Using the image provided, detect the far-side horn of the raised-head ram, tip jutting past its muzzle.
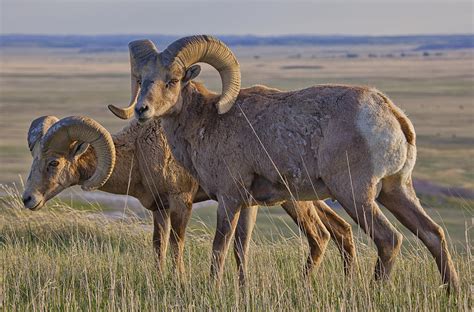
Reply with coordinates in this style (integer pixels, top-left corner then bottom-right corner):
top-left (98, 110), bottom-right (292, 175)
top-left (108, 40), bottom-right (158, 119)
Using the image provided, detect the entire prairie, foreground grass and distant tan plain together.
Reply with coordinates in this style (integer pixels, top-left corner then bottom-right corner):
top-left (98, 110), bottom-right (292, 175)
top-left (0, 47), bottom-right (474, 311)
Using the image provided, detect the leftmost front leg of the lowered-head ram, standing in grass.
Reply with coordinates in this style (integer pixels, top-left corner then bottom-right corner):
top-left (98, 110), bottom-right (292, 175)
top-left (153, 209), bottom-right (170, 271)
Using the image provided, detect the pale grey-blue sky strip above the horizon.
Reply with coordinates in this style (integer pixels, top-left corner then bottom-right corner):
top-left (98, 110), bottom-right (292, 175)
top-left (0, 0), bottom-right (474, 35)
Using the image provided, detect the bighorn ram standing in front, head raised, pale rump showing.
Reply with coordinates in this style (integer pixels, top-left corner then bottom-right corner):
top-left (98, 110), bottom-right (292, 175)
top-left (111, 36), bottom-right (459, 290)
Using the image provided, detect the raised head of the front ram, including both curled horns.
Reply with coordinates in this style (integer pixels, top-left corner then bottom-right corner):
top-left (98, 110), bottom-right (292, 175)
top-left (109, 35), bottom-right (240, 121)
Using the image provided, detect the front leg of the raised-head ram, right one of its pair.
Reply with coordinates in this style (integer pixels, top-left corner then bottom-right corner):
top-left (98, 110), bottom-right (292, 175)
top-left (234, 206), bottom-right (258, 286)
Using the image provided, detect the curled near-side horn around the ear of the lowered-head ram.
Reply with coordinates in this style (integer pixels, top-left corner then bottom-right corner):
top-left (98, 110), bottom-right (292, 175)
top-left (41, 116), bottom-right (115, 190)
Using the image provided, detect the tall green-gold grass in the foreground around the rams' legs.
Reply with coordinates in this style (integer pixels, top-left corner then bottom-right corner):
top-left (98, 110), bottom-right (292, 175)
top-left (0, 189), bottom-right (474, 311)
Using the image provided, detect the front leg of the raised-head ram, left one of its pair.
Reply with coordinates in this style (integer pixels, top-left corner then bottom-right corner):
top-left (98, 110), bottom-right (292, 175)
top-left (211, 196), bottom-right (241, 283)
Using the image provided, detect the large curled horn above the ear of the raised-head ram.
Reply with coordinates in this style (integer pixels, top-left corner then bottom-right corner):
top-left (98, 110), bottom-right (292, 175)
top-left (160, 35), bottom-right (241, 114)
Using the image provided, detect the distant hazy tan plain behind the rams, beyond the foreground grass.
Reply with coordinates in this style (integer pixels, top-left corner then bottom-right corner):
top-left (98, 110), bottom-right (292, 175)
top-left (0, 46), bottom-right (474, 189)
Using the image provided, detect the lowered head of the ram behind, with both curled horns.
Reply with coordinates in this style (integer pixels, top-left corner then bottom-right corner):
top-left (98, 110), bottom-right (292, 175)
top-left (23, 116), bottom-right (115, 210)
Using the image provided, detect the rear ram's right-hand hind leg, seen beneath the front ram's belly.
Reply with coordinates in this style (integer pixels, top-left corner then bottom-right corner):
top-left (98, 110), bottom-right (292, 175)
top-left (313, 200), bottom-right (356, 275)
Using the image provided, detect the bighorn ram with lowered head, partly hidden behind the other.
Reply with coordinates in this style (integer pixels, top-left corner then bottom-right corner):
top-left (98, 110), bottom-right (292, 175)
top-left (23, 116), bottom-right (355, 279)
